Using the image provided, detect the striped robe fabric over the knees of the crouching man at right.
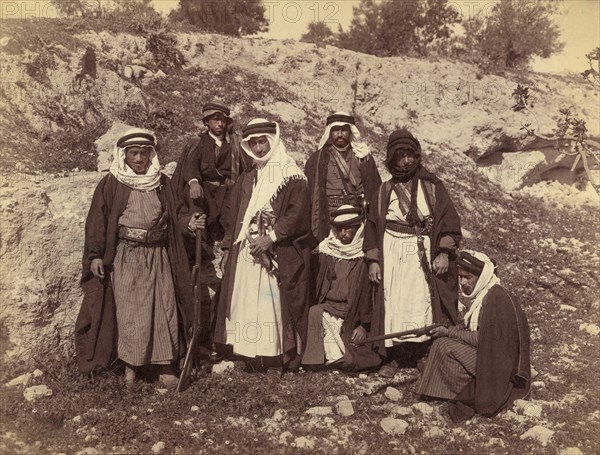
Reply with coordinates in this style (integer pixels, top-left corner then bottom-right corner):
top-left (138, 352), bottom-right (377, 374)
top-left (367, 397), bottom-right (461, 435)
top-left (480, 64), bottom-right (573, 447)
top-left (418, 337), bottom-right (477, 400)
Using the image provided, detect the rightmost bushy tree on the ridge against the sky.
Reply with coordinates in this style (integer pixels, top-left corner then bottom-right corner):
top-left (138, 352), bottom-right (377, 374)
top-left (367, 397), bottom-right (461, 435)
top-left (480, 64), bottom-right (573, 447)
top-left (466, 0), bottom-right (563, 69)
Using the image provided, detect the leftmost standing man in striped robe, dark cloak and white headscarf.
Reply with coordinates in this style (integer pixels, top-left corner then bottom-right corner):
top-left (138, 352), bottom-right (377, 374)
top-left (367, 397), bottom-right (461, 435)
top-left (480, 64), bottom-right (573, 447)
top-left (75, 128), bottom-right (192, 386)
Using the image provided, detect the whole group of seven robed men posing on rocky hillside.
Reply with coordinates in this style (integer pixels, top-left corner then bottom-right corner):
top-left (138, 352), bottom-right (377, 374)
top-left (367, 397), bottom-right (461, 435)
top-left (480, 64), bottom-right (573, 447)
top-left (77, 102), bottom-right (529, 418)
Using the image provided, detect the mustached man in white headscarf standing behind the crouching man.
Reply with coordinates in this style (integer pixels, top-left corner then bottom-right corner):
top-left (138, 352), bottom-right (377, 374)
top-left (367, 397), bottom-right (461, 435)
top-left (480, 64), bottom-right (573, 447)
top-left (305, 112), bottom-right (381, 242)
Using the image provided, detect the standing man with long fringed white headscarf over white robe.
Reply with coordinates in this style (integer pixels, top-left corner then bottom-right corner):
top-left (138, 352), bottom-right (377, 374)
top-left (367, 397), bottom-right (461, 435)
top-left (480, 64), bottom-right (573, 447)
top-left (215, 119), bottom-right (309, 374)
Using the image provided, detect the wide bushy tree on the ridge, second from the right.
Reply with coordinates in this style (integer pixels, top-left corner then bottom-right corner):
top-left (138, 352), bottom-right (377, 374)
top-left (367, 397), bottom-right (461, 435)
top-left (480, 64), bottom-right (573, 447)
top-left (338, 0), bottom-right (460, 56)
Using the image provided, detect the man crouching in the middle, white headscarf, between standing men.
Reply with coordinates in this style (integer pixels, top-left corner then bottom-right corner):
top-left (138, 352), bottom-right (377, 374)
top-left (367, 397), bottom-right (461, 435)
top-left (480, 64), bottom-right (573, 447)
top-left (302, 205), bottom-right (380, 370)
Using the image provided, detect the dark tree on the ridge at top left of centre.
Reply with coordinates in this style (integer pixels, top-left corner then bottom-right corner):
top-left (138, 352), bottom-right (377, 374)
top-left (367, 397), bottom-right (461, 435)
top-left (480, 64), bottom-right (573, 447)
top-left (170, 0), bottom-right (269, 36)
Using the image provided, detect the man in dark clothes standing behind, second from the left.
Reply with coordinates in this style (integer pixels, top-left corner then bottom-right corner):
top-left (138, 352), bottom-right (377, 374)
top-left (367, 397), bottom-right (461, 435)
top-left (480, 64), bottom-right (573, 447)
top-left (172, 101), bottom-right (249, 356)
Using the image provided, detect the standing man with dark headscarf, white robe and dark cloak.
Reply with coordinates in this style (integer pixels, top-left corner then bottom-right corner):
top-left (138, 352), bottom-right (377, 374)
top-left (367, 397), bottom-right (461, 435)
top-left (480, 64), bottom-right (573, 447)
top-left (363, 129), bottom-right (461, 377)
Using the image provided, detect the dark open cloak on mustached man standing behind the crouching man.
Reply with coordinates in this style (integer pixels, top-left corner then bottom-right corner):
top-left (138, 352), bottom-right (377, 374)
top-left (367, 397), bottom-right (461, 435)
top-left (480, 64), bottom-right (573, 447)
top-left (304, 146), bottom-right (381, 246)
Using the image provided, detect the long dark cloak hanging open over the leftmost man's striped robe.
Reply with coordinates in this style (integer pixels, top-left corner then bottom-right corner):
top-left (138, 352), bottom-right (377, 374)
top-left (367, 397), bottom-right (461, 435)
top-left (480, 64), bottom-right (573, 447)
top-left (75, 174), bottom-right (192, 373)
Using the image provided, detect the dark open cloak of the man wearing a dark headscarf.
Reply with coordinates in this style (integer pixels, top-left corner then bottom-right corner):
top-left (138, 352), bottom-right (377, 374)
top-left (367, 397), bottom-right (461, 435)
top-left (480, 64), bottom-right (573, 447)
top-left (363, 169), bottom-right (462, 356)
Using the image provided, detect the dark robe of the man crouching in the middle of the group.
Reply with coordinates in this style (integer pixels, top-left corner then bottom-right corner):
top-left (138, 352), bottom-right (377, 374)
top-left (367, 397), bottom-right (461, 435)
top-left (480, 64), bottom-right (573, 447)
top-left (302, 253), bottom-right (379, 370)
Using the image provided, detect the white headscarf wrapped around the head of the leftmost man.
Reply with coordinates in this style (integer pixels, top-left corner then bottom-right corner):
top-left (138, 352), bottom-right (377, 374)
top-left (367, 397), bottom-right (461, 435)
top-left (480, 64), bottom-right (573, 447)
top-left (109, 128), bottom-right (160, 191)
